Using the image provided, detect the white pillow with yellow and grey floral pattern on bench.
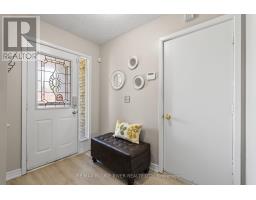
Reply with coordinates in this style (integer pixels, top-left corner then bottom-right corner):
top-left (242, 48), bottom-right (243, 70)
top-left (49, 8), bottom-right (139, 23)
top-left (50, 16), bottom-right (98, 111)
top-left (114, 120), bottom-right (142, 144)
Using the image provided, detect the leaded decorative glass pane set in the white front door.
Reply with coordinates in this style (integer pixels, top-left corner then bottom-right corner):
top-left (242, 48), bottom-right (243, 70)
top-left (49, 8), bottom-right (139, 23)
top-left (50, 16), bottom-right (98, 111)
top-left (37, 54), bottom-right (71, 108)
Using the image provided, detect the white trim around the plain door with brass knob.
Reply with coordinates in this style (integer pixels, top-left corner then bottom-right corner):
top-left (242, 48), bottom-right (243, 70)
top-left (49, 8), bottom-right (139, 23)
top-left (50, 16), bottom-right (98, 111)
top-left (158, 15), bottom-right (242, 184)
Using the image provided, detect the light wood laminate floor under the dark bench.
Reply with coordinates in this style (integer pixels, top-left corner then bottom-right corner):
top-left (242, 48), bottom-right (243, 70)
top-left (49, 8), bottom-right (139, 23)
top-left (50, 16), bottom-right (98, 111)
top-left (7, 153), bottom-right (185, 185)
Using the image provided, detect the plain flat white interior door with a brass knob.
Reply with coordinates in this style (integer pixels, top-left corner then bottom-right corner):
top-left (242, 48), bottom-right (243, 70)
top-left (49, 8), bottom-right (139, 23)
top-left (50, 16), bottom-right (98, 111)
top-left (164, 21), bottom-right (234, 184)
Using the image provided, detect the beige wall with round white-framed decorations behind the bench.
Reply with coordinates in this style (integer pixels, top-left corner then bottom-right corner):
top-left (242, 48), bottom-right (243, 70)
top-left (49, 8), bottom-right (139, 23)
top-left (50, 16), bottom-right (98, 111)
top-left (100, 15), bottom-right (220, 163)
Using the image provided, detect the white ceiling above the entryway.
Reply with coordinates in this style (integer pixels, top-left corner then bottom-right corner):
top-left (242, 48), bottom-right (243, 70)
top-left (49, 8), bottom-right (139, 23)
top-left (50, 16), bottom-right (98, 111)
top-left (40, 14), bottom-right (160, 44)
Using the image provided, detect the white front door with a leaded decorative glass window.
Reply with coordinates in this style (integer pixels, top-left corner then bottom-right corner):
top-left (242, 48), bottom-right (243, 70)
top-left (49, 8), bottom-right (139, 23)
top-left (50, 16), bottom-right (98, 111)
top-left (27, 45), bottom-right (78, 170)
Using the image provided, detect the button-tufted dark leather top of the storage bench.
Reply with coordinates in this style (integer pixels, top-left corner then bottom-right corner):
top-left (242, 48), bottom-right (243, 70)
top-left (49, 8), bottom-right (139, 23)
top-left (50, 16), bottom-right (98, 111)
top-left (92, 132), bottom-right (150, 158)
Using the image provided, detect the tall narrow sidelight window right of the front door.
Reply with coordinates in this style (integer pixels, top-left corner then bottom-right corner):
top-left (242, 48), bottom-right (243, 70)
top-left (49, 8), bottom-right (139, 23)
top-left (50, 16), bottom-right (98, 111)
top-left (79, 58), bottom-right (89, 141)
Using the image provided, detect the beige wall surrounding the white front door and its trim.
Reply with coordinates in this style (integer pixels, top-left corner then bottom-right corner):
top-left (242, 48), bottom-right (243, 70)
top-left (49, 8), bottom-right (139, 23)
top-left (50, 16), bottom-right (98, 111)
top-left (7, 21), bottom-right (99, 171)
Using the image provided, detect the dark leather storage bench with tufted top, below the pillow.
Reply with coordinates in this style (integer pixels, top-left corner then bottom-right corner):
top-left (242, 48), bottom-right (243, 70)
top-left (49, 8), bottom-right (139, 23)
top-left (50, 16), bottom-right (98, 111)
top-left (91, 133), bottom-right (150, 184)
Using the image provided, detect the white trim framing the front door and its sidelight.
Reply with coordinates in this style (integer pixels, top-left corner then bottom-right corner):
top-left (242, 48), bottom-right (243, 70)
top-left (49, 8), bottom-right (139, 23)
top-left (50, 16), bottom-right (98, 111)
top-left (21, 40), bottom-right (92, 175)
